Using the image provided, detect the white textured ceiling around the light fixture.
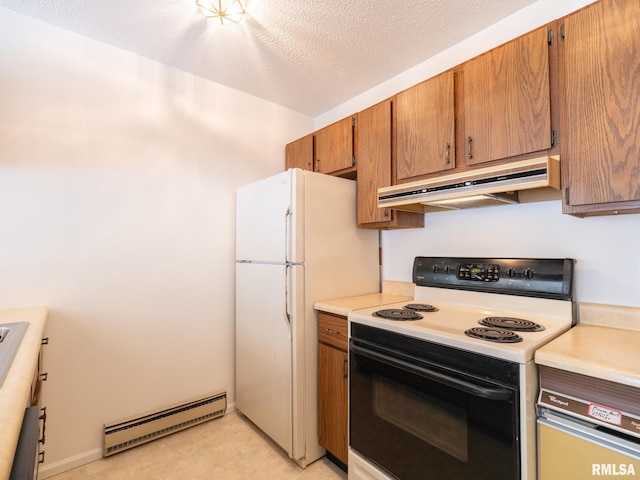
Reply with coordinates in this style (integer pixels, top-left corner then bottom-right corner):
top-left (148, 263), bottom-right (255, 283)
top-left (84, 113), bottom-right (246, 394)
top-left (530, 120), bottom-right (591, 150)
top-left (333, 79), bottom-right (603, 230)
top-left (0, 0), bottom-right (535, 117)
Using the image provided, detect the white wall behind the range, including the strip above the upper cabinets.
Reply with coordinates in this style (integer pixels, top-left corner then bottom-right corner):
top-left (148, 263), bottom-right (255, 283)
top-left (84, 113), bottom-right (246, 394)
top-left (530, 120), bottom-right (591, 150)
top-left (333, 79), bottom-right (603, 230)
top-left (314, 0), bottom-right (640, 306)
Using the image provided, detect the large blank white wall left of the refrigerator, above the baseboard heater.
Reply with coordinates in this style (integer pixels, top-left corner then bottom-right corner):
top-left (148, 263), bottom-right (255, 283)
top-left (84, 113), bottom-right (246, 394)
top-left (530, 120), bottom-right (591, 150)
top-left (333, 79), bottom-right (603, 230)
top-left (0, 9), bottom-right (313, 475)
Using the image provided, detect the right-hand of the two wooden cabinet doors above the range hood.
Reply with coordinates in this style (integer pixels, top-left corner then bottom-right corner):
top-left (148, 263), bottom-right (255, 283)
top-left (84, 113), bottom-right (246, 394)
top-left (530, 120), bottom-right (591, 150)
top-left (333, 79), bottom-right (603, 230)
top-left (461, 27), bottom-right (551, 165)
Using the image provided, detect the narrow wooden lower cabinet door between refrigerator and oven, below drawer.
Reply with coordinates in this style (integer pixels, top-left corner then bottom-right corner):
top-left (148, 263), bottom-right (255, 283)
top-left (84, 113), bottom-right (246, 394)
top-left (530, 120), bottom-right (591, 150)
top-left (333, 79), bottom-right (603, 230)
top-left (318, 343), bottom-right (349, 465)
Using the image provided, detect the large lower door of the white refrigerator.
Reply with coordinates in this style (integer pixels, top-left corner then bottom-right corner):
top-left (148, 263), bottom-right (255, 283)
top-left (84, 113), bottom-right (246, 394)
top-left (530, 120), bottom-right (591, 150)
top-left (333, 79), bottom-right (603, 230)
top-left (236, 263), bottom-right (293, 456)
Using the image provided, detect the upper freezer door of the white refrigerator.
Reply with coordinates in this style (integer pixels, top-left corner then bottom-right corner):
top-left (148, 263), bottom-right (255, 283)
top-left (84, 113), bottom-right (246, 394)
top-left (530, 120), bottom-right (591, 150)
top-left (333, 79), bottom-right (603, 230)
top-left (236, 170), bottom-right (304, 263)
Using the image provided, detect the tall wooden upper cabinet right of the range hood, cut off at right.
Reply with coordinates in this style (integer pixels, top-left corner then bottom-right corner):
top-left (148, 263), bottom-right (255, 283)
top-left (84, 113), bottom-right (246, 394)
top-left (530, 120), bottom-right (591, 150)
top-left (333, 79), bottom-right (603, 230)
top-left (560, 0), bottom-right (640, 213)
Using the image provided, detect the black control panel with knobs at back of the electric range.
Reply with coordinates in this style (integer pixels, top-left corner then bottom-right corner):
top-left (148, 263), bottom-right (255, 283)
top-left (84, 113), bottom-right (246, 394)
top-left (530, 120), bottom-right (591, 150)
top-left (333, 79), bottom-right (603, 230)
top-left (413, 257), bottom-right (575, 300)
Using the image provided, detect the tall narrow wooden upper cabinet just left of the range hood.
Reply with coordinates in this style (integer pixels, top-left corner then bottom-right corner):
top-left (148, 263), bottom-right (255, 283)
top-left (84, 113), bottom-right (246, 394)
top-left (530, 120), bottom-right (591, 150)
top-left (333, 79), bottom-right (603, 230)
top-left (356, 99), bottom-right (424, 229)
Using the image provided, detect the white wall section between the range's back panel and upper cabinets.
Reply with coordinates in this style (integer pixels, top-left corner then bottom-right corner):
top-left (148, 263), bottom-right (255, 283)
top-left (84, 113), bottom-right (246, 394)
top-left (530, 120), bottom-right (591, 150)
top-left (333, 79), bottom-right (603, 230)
top-left (382, 200), bottom-right (640, 307)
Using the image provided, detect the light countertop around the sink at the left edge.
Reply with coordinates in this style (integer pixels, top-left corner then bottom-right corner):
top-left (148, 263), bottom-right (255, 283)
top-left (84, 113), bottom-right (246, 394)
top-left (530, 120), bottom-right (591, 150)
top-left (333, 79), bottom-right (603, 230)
top-left (0, 307), bottom-right (47, 480)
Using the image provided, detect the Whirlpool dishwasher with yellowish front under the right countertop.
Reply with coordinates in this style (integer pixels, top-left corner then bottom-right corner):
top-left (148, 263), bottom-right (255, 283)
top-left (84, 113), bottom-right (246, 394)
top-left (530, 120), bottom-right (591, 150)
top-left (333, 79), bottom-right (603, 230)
top-left (537, 366), bottom-right (640, 480)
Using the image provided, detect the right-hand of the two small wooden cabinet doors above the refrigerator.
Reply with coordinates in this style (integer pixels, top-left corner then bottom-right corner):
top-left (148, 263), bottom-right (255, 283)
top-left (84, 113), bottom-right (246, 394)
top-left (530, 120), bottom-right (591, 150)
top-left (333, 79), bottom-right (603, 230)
top-left (315, 117), bottom-right (355, 173)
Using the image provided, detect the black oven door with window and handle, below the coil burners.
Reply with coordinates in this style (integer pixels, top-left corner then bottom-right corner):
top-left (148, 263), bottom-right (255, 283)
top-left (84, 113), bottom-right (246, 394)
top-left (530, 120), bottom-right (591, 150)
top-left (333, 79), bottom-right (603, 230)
top-left (349, 325), bottom-right (520, 480)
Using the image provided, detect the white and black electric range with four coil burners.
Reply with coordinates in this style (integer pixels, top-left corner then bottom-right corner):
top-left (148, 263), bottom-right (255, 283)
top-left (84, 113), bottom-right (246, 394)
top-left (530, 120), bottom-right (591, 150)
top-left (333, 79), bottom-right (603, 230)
top-left (349, 257), bottom-right (575, 480)
